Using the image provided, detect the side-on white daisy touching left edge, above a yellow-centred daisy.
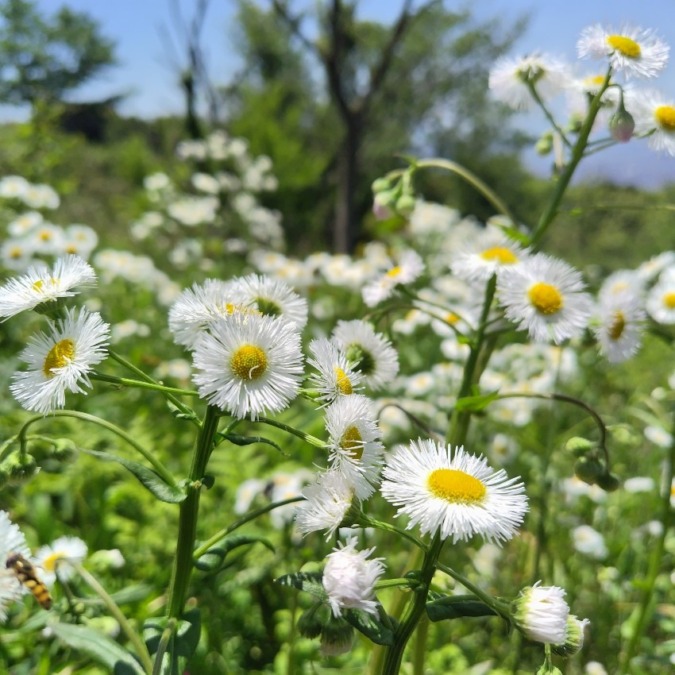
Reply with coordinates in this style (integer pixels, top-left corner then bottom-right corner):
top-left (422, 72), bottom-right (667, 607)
top-left (0, 255), bottom-right (96, 319)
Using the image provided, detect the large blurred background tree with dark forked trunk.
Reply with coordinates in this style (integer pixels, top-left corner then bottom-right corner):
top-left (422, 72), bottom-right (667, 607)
top-left (230, 0), bottom-right (522, 251)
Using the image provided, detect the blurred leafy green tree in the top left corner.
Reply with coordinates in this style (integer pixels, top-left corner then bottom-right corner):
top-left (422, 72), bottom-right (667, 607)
top-left (0, 0), bottom-right (115, 106)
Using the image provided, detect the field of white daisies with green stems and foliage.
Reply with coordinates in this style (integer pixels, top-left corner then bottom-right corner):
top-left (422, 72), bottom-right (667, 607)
top-left (0, 7), bottom-right (675, 675)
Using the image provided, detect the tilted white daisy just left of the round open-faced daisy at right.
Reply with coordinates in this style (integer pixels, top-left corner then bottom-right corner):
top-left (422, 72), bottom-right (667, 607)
top-left (450, 227), bottom-right (527, 281)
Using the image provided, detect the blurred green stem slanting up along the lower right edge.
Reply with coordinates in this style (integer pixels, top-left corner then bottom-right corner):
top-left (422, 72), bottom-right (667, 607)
top-left (618, 415), bottom-right (675, 675)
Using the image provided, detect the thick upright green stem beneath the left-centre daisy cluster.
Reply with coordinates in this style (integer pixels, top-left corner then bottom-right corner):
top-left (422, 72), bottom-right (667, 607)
top-left (168, 406), bottom-right (220, 619)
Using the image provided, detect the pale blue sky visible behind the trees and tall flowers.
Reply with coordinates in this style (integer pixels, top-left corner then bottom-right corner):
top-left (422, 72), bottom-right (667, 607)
top-left (0, 0), bottom-right (675, 182)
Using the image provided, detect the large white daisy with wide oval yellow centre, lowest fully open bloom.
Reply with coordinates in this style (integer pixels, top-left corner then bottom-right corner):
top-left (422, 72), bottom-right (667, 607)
top-left (381, 439), bottom-right (527, 543)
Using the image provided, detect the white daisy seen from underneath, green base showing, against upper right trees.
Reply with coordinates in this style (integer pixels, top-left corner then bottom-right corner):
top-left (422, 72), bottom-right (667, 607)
top-left (489, 54), bottom-right (572, 110)
